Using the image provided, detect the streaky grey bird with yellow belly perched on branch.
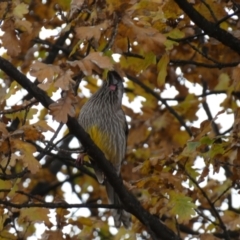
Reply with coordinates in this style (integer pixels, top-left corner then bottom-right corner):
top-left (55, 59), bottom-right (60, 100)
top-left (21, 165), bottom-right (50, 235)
top-left (78, 70), bottom-right (131, 229)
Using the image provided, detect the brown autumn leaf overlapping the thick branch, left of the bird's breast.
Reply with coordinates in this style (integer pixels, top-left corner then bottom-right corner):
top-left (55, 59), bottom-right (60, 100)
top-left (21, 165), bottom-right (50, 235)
top-left (49, 91), bottom-right (77, 123)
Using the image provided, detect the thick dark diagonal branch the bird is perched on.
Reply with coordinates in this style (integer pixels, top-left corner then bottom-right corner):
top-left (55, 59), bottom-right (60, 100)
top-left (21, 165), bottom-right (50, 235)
top-left (0, 57), bottom-right (179, 240)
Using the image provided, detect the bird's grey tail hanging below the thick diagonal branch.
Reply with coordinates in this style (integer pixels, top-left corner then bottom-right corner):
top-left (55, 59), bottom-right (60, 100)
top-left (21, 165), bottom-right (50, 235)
top-left (106, 181), bottom-right (131, 228)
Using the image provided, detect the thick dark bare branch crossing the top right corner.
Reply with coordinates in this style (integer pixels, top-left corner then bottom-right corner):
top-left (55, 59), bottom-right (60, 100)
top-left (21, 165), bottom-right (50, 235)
top-left (175, 0), bottom-right (240, 54)
